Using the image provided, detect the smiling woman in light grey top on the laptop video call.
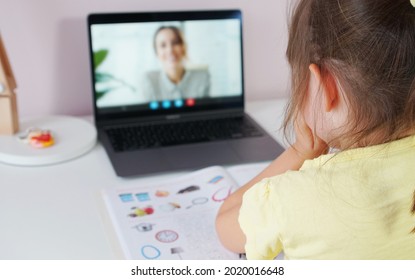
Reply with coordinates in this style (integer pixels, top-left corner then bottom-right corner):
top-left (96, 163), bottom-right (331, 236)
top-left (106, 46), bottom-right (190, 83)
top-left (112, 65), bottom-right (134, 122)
top-left (143, 26), bottom-right (210, 101)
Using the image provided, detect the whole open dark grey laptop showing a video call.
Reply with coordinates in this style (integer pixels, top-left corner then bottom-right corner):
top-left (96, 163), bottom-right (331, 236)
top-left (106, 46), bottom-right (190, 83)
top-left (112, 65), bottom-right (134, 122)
top-left (88, 10), bottom-right (283, 177)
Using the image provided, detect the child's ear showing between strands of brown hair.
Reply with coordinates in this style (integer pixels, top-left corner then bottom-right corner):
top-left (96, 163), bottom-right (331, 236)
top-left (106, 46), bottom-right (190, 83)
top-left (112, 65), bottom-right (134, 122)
top-left (309, 64), bottom-right (339, 112)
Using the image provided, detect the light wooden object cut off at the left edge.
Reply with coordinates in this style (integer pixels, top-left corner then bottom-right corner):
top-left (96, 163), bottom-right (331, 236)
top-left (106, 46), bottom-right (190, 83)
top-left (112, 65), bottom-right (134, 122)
top-left (0, 34), bottom-right (19, 135)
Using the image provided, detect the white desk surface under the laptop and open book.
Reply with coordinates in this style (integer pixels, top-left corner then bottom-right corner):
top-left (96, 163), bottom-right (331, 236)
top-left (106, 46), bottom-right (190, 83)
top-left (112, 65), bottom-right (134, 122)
top-left (0, 99), bottom-right (286, 259)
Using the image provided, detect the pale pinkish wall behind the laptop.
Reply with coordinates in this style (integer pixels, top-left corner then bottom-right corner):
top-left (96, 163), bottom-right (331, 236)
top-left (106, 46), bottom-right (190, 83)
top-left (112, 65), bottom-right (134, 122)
top-left (0, 0), bottom-right (289, 117)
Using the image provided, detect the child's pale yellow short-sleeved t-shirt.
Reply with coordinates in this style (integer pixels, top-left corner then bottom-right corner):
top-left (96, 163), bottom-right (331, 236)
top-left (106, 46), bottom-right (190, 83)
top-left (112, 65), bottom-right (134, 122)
top-left (239, 136), bottom-right (415, 259)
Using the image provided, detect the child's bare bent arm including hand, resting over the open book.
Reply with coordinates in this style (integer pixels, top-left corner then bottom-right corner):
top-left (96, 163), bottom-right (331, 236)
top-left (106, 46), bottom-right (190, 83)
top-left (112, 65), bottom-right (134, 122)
top-left (216, 115), bottom-right (327, 253)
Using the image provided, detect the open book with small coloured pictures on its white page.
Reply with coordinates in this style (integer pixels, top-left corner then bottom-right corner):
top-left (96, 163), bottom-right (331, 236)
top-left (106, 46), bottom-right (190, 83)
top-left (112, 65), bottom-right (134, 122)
top-left (103, 163), bottom-right (268, 260)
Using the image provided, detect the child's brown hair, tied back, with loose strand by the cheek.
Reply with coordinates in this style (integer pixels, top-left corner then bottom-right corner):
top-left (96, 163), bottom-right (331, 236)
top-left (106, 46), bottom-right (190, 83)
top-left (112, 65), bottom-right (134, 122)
top-left (284, 0), bottom-right (415, 149)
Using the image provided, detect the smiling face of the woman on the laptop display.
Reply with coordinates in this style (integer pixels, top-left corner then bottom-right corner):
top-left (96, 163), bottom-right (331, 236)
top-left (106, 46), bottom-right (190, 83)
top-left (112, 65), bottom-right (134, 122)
top-left (155, 28), bottom-right (185, 68)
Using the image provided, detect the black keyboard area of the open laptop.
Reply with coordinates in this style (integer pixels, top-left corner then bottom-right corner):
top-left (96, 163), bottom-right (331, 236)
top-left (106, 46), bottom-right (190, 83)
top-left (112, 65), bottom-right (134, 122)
top-left (106, 117), bottom-right (263, 152)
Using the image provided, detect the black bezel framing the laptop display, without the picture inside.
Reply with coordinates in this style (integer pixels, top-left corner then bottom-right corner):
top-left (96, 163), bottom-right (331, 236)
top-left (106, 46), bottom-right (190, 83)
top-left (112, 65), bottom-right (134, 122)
top-left (88, 10), bottom-right (245, 121)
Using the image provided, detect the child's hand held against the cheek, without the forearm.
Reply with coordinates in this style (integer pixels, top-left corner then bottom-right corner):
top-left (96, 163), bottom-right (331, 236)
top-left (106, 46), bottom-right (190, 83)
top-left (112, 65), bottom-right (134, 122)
top-left (293, 116), bottom-right (328, 160)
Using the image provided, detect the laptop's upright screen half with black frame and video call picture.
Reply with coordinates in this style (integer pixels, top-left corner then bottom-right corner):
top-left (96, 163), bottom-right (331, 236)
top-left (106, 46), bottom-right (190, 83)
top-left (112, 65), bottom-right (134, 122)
top-left (88, 10), bottom-right (244, 121)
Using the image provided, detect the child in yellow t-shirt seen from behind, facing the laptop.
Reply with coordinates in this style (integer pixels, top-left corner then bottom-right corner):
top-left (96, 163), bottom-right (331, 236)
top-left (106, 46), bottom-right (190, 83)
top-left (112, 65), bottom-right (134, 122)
top-left (216, 0), bottom-right (415, 259)
